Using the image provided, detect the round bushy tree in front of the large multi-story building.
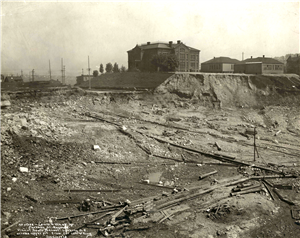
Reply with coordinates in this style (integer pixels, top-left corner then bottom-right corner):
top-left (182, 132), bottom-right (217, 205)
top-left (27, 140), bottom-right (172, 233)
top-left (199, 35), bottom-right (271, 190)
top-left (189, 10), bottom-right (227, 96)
top-left (151, 54), bottom-right (179, 72)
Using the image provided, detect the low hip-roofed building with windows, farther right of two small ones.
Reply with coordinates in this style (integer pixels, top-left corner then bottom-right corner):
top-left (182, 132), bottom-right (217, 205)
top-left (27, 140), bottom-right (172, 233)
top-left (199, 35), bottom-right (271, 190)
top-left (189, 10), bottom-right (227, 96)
top-left (234, 55), bottom-right (284, 74)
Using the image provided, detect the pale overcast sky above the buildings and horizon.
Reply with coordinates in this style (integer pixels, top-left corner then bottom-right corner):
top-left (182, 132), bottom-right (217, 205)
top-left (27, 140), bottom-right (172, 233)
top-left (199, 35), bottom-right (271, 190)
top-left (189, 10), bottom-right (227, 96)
top-left (0, 0), bottom-right (299, 75)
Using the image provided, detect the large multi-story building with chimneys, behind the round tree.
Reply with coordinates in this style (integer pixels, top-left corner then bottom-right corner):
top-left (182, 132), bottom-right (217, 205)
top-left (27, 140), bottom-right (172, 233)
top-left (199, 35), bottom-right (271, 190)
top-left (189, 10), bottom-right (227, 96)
top-left (127, 40), bottom-right (200, 72)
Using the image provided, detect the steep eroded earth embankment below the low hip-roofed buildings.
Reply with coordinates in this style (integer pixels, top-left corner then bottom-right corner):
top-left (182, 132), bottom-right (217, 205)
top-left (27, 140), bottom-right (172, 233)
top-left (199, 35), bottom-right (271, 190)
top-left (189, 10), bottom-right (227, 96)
top-left (155, 73), bottom-right (300, 107)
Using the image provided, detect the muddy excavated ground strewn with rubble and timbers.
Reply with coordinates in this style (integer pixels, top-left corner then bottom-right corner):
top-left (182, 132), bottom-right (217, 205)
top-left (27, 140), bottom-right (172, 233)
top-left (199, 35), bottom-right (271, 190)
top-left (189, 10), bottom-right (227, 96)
top-left (0, 90), bottom-right (300, 238)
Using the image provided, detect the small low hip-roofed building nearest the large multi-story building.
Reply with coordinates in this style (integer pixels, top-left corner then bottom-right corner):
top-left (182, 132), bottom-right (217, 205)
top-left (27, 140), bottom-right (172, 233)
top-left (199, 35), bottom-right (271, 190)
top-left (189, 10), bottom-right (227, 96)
top-left (201, 57), bottom-right (240, 73)
